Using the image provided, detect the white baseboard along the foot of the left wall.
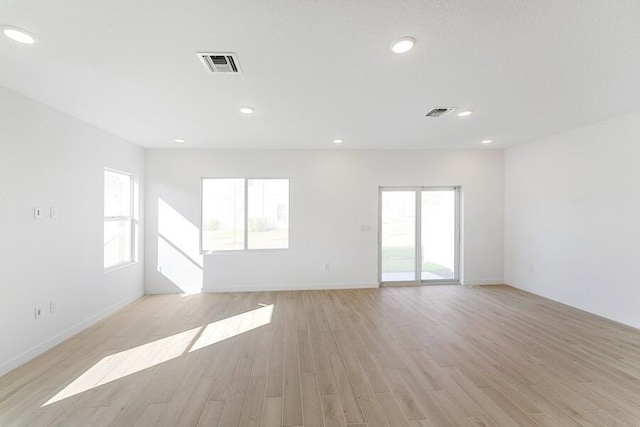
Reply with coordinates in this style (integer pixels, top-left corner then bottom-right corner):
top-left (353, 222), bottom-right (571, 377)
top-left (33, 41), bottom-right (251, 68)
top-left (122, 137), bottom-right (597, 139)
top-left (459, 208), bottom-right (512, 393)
top-left (0, 293), bottom-right (144, 376)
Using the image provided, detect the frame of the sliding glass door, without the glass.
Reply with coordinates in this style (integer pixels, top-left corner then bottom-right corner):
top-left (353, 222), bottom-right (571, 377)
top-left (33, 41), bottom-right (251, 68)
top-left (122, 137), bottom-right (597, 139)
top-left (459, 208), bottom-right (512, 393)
top-left (378, 186), bottom-right (461, 286)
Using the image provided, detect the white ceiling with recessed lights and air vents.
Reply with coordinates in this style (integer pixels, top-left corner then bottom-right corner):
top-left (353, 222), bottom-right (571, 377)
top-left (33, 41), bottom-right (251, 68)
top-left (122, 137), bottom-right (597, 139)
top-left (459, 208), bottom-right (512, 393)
top-left (0, 0), bottom-right (640, 149)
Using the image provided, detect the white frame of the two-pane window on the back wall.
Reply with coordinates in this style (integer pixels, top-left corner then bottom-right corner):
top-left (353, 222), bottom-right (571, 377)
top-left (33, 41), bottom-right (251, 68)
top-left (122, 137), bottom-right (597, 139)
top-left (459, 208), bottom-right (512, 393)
top-left (199, 176), bottom-right (291, 255)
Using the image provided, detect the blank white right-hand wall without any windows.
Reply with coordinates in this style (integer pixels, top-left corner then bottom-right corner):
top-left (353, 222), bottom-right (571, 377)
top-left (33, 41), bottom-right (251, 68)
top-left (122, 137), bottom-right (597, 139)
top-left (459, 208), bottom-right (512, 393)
top-left (505, 112), bottom-right (640, 328)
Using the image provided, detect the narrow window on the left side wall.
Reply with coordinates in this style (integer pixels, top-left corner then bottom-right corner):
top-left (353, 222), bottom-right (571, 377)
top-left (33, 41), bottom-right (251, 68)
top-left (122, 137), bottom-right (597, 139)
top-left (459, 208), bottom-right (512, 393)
top-left (104, 170), bottom-right (135, 270)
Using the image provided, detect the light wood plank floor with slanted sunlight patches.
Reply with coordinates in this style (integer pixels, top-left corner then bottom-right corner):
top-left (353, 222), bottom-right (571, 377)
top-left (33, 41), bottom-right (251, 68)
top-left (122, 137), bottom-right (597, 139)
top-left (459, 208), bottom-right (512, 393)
top-left (0, 286), bottom-right (640, 427)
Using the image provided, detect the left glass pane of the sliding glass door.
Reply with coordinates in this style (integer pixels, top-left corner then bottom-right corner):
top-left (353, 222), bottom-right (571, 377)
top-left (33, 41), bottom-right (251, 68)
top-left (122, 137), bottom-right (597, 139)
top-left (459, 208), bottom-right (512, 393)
top-left (381, 191), bottom-right (416, 282)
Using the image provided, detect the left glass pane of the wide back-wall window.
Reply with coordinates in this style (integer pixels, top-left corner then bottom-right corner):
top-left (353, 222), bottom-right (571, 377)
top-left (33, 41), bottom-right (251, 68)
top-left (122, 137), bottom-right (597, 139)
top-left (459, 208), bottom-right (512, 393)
top-left (202, 179), bottom-right (244, 251)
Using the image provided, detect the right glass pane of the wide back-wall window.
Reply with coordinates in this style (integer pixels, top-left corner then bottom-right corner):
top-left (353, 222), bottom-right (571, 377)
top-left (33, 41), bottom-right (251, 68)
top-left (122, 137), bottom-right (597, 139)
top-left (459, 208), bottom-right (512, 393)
top-left (247, 179), bottom-right (289, 249)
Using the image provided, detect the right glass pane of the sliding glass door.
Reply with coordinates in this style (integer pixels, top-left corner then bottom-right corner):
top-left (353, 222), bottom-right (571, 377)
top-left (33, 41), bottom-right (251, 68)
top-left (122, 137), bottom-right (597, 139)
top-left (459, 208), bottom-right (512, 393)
top-left (421, 190), bottom-right (456, 280)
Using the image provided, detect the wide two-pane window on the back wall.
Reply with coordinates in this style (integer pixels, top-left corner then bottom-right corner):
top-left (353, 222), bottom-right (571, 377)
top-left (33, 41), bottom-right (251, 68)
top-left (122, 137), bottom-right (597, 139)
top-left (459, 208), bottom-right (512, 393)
top-left (202, 178), bottom-right (289, 252)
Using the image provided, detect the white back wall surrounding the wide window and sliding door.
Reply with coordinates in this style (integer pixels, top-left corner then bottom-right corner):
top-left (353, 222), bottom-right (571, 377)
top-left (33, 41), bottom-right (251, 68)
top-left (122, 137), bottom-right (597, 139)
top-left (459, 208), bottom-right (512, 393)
top-left (145, 147), bottom-right (504, 293)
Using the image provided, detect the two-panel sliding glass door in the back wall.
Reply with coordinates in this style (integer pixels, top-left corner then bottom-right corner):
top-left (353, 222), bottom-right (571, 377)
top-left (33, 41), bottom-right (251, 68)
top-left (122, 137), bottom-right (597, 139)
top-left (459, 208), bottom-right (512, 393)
top-left (379, 187), bottom-right (459, 283)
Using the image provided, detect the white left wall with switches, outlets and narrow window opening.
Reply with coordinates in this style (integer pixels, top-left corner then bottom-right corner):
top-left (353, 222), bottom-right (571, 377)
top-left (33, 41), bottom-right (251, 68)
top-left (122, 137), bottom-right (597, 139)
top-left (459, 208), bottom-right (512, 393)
top-left (0, 86), bottom-right (144, 375)
